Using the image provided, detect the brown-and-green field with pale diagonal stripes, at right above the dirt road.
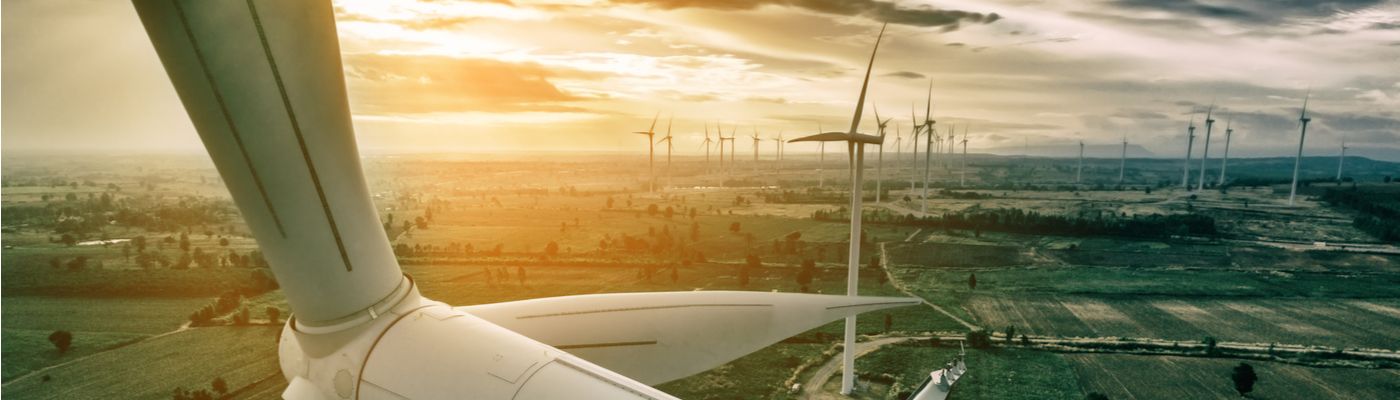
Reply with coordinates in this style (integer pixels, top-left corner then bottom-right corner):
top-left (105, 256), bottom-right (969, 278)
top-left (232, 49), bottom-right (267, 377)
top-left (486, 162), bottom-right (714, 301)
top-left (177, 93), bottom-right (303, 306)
top-left (967, 295), bottom-right (1400, 350)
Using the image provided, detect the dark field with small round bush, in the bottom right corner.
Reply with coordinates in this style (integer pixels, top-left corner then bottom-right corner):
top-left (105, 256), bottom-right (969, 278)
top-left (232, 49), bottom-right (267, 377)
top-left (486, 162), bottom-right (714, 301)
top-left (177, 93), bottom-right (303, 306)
top-left (1064, 354), bottom-right (1400, 400)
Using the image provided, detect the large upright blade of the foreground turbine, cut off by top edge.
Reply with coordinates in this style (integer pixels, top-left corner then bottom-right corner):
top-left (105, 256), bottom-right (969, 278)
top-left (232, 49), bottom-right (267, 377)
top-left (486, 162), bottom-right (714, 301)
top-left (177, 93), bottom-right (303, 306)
top-left (134, 0), bottom-right (405, 326)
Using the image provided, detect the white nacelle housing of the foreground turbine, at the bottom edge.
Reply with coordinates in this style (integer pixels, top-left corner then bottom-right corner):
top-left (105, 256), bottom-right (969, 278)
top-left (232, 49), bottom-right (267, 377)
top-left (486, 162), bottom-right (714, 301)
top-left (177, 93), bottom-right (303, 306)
top-left (361, 303), bottom-right (675, 399)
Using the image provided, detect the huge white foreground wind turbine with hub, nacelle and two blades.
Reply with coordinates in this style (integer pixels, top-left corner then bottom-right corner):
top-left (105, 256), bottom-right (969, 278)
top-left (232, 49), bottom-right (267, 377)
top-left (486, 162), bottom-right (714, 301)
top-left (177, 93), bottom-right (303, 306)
top-left (133, 0), bottom-right (918, 400)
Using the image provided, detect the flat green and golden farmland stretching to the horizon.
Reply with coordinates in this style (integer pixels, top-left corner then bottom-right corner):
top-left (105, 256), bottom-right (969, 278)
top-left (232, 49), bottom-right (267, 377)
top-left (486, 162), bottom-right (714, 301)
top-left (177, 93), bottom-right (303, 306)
top-left (0, 151), bottom-right (1400, 399)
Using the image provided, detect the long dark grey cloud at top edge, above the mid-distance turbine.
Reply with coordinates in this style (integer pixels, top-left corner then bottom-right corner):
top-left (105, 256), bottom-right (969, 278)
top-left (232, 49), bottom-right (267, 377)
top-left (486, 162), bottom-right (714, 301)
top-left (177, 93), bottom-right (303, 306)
top-left (612, 0), bottom-right (1001, 31)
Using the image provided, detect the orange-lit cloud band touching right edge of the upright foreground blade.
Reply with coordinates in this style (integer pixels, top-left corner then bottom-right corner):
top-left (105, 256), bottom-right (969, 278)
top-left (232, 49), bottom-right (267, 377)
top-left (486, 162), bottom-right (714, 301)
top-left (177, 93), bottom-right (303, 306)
top-left (346, 55), bottom-right (595, 115)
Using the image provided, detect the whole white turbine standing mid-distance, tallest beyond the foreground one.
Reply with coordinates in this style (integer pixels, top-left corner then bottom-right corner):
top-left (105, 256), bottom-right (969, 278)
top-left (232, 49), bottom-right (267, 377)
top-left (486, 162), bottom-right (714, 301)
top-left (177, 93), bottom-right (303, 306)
top-left (792, 25), bottom-right (885, 394)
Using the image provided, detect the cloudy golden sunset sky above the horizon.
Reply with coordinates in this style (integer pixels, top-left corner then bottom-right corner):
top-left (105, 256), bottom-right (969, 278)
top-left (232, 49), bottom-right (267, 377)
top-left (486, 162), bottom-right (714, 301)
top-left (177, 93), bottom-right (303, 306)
top-left (8, 0), bottom-right (1400, 158)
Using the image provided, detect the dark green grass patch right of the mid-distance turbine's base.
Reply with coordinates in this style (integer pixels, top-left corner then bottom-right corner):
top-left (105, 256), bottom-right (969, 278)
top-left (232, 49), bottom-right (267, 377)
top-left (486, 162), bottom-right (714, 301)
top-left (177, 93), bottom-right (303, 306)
top-left (855, 344), bottom-right (1084, 400)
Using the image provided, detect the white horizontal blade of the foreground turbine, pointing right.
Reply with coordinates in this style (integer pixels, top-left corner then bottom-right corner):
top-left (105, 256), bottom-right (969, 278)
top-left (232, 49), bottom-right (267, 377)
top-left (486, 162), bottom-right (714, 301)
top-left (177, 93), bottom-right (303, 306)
top-left (458, 291), bottom-right (920, 385)
